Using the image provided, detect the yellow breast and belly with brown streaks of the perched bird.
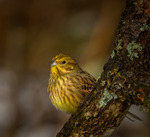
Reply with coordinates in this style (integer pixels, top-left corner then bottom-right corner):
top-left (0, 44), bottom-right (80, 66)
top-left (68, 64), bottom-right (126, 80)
top-left (48, 78), bottom-right (81, 113)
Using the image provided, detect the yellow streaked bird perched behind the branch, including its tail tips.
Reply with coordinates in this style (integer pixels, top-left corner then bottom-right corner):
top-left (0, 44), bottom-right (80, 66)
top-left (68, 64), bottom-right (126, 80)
top-left (48, 53), bottom-right (142, 121)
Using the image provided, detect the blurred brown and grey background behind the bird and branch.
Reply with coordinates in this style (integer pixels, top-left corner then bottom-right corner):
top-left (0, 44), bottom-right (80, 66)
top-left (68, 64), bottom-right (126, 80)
top-left (0, 0), bottom-right (150, 137)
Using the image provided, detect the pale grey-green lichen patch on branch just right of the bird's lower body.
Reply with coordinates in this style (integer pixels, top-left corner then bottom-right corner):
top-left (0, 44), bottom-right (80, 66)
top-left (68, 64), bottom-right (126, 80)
top-left (98, 88), bottom-right (118, 108)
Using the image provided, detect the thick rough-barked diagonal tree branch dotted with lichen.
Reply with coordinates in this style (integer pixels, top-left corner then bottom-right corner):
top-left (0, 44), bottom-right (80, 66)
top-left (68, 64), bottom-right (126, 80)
top-left (57, 0), bottom-right (150, 137)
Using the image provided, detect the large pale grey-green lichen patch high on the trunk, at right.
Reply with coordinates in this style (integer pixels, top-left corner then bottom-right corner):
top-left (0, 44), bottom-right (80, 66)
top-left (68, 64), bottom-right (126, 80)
top-left (127, 41), bottom-right (142, 61)
